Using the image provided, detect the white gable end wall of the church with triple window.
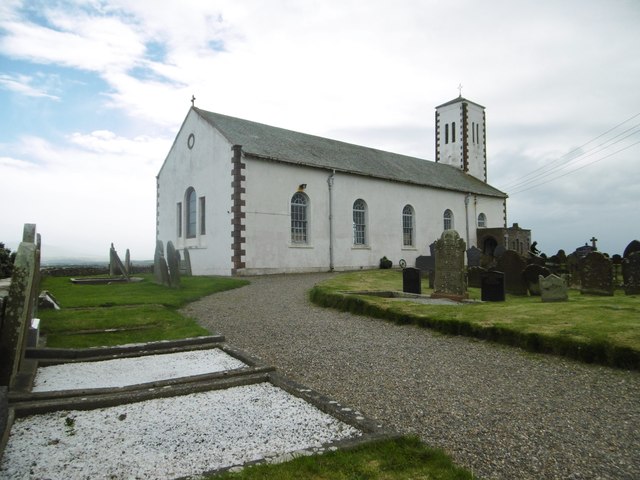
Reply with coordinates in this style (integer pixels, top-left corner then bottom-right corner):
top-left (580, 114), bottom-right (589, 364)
top-left (158, 111), bottom-right (232, 275)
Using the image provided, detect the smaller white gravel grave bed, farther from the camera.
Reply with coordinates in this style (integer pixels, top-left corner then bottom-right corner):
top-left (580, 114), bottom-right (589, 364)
top-left (32, 348), bottom-right (247, 392)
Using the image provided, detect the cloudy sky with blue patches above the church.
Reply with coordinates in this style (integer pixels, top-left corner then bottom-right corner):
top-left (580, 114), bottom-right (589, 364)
top-left (0, 0), bottom-right (640, 260)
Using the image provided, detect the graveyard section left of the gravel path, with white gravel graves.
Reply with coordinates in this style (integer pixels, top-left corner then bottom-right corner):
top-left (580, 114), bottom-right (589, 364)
top-left (0, 225), bottom-right (472, 479)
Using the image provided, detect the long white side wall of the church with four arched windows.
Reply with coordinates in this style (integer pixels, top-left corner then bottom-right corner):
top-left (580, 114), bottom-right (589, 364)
top-left (240, 159), bottom-right (502, 275)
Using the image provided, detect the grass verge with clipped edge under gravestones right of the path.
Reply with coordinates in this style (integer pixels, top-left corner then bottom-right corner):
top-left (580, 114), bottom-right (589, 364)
top-left (310, 270), bottom-right (640, 370)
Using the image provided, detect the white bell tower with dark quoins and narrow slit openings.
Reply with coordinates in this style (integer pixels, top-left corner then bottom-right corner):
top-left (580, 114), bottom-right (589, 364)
top-left (436, 92), bottom-right (487, 182)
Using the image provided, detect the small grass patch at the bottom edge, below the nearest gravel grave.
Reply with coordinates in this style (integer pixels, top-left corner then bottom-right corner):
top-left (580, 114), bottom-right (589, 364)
top-left (209, 437), bottom-right (474, 480)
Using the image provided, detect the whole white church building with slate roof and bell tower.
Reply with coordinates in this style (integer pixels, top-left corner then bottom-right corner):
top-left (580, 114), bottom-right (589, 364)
top-left (156, 96), bottom-right (507, 275)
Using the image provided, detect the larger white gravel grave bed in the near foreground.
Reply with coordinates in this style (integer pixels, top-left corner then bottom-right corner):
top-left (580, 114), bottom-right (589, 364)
top-left (0, 383), bottom-right (362, 480)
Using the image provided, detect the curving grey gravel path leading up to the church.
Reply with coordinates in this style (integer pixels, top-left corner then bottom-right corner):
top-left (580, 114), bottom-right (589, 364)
top-left (183, 274), bottom-right (640, 480)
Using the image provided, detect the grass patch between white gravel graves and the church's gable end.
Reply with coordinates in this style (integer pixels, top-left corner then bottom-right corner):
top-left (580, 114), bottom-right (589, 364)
top-left (38, 275), bottom-right (248, 348)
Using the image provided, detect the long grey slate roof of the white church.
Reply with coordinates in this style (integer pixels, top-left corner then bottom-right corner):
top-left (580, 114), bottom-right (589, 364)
top-left (192, 107), bottom-right (507, 198)
